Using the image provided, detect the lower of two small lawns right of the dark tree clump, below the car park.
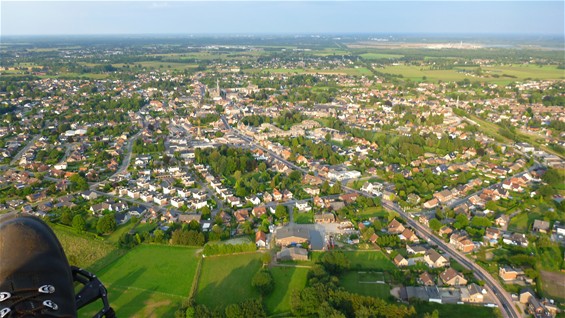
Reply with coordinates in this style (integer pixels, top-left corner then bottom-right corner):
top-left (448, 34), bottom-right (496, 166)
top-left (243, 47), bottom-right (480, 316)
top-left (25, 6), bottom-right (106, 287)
top-left (339, 271), bottom-right (390, 299)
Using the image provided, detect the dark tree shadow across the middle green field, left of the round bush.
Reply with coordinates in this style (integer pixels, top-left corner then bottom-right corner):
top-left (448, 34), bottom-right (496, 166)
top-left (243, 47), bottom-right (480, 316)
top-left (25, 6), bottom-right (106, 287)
top-left (196, 260), bottom-right (260, 308)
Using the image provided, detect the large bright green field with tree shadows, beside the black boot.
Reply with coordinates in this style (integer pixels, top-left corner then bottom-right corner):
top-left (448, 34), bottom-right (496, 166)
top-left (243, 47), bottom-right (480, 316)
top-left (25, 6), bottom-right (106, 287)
top-left (81, 245), bottom-right (198, 317)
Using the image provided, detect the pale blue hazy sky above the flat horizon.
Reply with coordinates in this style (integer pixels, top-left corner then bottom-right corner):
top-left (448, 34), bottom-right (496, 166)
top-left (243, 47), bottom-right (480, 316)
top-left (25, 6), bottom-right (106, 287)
top-left (0, 0), bottom-right (565, 36)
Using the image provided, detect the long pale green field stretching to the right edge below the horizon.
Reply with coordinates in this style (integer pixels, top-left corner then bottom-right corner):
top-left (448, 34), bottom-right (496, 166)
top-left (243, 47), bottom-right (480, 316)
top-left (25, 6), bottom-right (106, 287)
top-left (377, 64), bottom-right (565, 84)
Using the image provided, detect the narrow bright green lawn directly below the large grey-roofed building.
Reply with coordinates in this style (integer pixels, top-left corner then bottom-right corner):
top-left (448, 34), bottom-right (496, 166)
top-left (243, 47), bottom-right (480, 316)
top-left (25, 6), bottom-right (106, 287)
top-left (265, 267), bottom-right (308, 315)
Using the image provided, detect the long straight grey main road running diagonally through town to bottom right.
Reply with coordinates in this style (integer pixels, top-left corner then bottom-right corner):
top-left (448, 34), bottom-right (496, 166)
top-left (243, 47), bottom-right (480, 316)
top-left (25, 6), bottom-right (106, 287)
top-left (221, 116), bottom-right (521, 318)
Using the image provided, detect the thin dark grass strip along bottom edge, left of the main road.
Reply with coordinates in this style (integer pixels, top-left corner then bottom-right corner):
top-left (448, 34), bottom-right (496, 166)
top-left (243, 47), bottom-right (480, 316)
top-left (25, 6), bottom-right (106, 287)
top-left (413, 302), bottom-right (499, 318)
